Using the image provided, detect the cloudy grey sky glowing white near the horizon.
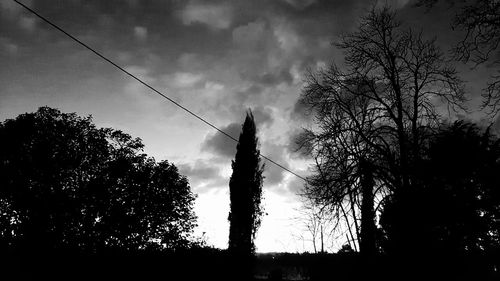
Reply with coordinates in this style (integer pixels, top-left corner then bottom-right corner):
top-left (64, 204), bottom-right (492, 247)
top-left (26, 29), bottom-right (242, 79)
top-left (0, 0), bottom-right (493, 252)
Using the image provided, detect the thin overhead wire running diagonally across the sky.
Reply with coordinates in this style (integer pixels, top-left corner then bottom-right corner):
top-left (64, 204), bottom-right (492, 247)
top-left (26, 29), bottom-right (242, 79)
top-left (12, 0), bottom-right (307, 181)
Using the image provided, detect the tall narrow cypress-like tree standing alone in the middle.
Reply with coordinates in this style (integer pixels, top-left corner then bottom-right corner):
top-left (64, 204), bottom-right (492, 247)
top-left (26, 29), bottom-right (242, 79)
top-left (228, 110), bottom-right (264, 256)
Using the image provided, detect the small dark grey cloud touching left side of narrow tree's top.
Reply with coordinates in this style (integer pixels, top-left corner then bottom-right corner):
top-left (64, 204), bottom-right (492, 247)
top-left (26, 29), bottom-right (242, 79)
top-left (201, 123), bottom-right (241, 159)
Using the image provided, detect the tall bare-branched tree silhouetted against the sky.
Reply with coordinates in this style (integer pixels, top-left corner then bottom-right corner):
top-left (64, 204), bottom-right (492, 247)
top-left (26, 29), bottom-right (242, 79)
top-left (299, 5), bottom-right (465, 254)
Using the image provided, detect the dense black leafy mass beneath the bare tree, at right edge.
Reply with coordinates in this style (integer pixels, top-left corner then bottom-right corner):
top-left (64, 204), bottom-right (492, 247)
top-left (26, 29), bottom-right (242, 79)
top-left (381, 122), bottom-right (500, 266)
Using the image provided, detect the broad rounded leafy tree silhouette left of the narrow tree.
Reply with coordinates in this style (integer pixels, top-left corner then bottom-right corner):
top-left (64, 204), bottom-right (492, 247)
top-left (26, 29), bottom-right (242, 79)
top-left (0, 107), bottom-right (196, 252)
